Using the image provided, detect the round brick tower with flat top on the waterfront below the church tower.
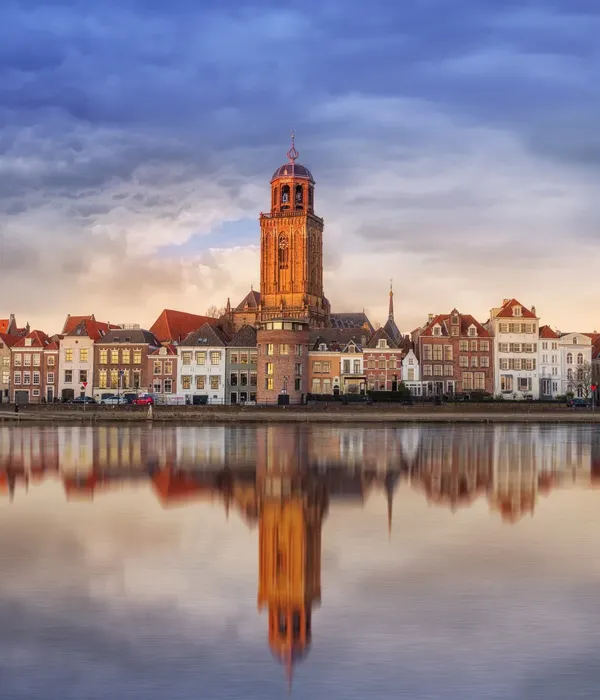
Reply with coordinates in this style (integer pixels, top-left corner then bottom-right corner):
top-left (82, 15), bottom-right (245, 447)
top-left (256, 318), bottom-right (310, 404)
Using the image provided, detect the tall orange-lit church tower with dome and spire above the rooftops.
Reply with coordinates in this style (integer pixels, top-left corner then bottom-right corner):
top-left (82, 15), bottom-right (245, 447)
top-left (260, 134), bottom-right (330, 328)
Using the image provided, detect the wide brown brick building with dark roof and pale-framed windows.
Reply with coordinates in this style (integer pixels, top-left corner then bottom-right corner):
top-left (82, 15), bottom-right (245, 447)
top-left (94, 328), bottom-right (160, 398)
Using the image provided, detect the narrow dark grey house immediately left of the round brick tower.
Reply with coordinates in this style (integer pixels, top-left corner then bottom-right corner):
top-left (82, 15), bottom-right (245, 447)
top-left (225, 325), bottom-right (258, 404)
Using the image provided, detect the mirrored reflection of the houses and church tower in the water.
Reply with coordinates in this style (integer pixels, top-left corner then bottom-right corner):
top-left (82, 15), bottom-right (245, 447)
top-left (0, 425), bottom-right (600, 696)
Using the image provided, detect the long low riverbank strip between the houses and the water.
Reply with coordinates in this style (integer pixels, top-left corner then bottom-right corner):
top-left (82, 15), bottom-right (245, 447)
top-left (0, 404), bottom-right (600, 424)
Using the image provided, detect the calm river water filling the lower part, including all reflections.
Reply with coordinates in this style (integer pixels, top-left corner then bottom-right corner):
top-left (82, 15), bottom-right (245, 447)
top-left (0, 426), bottom-right (600, 700)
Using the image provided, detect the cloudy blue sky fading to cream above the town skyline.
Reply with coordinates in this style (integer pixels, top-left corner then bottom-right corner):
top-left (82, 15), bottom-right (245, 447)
top-left (0, 0), bottom-right (600, 332)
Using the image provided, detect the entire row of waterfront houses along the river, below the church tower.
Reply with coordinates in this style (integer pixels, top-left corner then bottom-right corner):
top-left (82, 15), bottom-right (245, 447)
top-left (0, 291), bottom-right (600, 404)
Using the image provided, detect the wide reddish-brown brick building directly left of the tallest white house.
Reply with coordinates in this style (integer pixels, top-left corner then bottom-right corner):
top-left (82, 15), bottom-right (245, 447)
top-left (413, 309), bottom-right (494, 396)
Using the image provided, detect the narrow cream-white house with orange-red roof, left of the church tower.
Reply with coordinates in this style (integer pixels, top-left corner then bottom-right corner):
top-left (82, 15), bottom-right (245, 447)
top-left (58, 316), bottom-right (109, 400)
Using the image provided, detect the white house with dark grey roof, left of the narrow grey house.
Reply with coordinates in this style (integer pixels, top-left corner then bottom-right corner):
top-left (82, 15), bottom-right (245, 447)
top-left (177, 323), bottom-right (227, 404)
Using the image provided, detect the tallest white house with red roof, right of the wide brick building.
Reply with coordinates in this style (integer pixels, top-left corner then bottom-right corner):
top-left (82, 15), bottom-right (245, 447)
top-left (487, 299), bottom-right (540, 399)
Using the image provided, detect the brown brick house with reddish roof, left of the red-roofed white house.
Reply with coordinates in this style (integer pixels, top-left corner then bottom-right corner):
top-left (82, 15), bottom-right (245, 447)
top-left (11, 331), bottom-right (59, 403)
